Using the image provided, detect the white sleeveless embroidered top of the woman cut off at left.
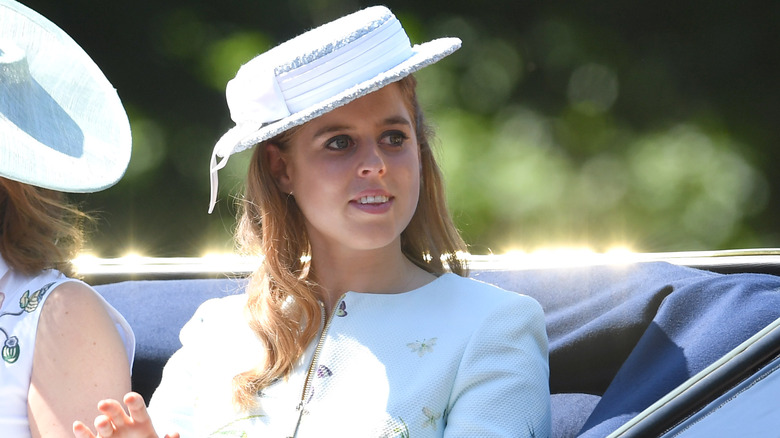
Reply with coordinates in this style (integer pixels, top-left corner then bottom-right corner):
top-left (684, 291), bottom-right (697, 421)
top-left (0, 258), bottom-right (135, 438)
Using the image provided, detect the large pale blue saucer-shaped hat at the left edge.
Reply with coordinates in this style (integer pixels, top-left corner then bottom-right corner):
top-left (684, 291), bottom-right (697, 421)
top-left (0, 0), bottom-right (131, 193)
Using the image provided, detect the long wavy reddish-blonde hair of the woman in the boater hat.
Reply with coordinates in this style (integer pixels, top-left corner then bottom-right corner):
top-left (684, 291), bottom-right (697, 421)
top-left (233, 75), bottom-right (468, 409)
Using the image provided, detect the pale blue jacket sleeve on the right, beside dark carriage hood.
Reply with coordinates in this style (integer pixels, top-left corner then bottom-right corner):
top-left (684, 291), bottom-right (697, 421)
top-left (444, 294), bottom-right (551, 438)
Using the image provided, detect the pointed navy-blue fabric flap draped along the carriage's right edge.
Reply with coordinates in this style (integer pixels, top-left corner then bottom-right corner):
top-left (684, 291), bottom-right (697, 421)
top-left (580, 268), bottom-right (780, 438)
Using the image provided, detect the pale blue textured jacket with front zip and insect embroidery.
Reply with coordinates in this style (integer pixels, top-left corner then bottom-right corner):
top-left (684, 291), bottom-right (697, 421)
top-left (150, 274), bottom-right (550, 437)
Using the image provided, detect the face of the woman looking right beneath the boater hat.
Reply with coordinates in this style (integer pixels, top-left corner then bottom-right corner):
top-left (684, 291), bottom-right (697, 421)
top-left (269, 83), bottom-right (420, 252)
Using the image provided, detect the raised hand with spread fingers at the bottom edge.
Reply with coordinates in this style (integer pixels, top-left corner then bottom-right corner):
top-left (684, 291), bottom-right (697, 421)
top-left (73, 392), bottom-right (179, 438)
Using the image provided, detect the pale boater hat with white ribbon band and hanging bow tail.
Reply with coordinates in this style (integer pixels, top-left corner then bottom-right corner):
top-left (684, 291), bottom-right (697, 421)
top-left (209, 6), bottom-right (461, 213)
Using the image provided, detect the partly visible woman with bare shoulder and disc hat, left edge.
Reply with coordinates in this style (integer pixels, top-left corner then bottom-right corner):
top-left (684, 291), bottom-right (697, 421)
top-left (0, 0), bottom-right (135, 438)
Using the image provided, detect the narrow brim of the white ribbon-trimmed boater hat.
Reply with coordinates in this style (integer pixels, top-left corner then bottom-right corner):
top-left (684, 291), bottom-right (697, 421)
top-left (220, 38), bottom-right (461, 156)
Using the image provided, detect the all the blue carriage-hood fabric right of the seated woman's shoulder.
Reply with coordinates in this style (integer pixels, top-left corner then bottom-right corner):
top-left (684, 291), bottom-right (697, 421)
top-left (475, 262), bottom-right (780, 438)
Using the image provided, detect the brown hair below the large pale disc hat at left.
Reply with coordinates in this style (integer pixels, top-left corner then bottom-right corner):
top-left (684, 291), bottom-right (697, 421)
top-left (0, 177), bottom-right (90, 276)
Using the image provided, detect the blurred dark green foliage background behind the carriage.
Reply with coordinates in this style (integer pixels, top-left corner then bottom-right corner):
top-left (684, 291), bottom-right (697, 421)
top-left (23, 0), bottom-right (780, 257)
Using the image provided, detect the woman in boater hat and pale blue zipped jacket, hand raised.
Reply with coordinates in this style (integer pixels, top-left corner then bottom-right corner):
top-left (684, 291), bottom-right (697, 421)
top-left (74, 7), bottom-right (550, 438)
